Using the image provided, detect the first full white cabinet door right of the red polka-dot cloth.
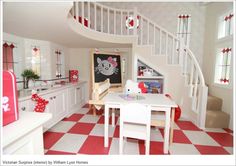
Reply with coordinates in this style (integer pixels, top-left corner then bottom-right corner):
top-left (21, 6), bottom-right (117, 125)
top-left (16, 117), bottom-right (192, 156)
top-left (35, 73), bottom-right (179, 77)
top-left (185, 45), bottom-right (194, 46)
top-left (53, 90), bottom-right (67, 121)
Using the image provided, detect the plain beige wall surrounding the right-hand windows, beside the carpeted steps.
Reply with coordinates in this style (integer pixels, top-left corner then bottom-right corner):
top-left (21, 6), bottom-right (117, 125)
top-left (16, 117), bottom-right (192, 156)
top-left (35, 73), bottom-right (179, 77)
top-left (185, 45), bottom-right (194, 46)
top-left (203, 2), bottom-right (235, 129)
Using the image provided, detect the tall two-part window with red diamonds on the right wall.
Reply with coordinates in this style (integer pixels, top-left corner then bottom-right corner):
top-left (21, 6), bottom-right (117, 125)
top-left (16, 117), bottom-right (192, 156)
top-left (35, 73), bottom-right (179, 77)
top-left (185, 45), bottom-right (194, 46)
top-left (214, 11), bottom-right (234, 86)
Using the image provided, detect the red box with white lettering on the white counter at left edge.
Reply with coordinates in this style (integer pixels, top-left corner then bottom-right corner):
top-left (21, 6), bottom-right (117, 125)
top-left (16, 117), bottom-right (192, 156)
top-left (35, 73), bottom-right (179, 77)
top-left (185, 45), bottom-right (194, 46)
top-left (2, 71), bottom-right (19, 126)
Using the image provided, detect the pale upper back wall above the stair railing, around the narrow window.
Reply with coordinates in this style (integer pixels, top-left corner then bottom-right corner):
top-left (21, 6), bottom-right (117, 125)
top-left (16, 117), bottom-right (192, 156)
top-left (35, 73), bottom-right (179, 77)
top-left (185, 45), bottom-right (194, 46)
top-left (102, 2), bottom-right (205, 66)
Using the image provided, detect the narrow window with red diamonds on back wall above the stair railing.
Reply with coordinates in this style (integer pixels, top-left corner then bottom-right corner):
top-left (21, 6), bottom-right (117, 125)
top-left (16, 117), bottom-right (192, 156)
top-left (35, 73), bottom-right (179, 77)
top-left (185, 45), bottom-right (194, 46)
top-left (177, 14), bottom-right (191, 46)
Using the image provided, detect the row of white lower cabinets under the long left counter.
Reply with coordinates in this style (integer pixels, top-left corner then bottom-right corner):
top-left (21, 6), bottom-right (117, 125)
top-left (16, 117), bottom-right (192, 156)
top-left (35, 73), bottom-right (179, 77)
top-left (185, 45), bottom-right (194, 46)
top-left (19, 83), bottom-right (86, 131)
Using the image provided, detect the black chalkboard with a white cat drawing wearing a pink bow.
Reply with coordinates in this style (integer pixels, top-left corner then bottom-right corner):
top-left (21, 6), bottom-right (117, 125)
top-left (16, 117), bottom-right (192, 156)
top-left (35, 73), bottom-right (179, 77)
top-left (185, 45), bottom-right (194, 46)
top-left (92, 53), bottom-right (122, 85)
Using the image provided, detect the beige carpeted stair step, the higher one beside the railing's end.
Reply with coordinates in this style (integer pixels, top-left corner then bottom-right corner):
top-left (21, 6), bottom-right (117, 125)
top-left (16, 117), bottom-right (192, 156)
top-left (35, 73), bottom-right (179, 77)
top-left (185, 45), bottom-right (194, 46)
top-left (207, 95), bottom-right (223, 111)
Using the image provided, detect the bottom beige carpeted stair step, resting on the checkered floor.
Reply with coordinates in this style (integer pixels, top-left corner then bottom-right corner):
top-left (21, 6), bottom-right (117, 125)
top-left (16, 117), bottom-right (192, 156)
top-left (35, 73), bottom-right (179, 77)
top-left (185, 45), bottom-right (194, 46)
top-left (205, 110), bottom-right (230, 128)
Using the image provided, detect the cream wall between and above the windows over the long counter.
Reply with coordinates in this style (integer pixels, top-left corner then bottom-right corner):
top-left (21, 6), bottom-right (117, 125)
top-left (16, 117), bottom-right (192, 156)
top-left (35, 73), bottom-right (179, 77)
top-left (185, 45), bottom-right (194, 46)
top-left (3, 32), bottom-right (69, 89)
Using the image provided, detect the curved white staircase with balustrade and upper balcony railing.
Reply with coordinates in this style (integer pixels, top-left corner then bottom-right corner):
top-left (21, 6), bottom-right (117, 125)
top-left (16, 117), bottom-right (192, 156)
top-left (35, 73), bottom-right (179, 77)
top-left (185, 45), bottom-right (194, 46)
top-left (67, 2), bottom-right (208, 128)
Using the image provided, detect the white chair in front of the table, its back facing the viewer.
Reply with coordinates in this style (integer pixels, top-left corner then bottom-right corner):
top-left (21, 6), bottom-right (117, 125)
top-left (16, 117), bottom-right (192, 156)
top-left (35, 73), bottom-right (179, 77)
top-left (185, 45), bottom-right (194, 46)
top-left (119, 103), bottom-right (151, 155)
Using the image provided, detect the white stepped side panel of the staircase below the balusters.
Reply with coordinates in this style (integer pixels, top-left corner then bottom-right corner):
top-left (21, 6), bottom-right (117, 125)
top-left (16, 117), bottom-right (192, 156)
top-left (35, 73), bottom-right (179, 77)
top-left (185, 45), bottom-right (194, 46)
top-left (134, 46), bottom-right (198, 125)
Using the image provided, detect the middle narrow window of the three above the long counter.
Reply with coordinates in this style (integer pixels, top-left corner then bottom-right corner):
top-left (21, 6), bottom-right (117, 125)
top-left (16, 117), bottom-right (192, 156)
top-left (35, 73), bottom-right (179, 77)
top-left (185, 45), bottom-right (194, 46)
top-left (31, 46), bottom-right (41, 76)
